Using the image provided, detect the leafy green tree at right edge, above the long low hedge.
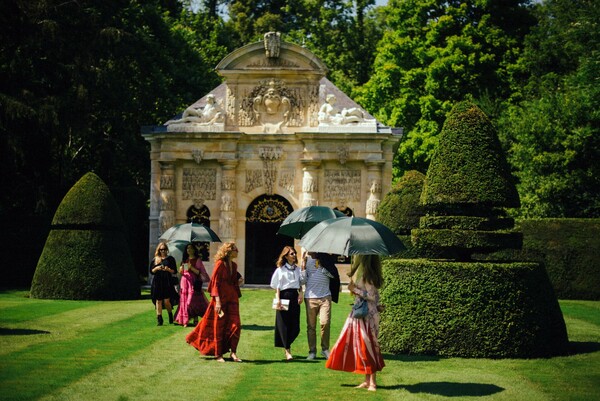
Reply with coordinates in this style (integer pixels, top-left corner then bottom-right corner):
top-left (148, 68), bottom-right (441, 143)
top-left (499, 0), bottom-right (600, 217)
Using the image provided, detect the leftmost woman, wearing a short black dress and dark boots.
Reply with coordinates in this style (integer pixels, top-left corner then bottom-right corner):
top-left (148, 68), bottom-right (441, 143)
top-left (150, 242), bottom-right (177, 326)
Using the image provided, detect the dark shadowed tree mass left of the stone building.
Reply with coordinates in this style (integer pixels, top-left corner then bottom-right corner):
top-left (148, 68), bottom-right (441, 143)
top-left (0, 0), bottom-right (218, 214)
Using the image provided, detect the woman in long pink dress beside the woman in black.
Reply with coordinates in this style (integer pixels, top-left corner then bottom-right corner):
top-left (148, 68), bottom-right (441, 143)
top-left (175, 243), bottom-right (210, 327)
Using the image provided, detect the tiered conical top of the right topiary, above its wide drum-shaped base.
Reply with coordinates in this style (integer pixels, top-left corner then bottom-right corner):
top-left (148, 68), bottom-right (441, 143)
top-left (412, 102), bottom-right (522, 261)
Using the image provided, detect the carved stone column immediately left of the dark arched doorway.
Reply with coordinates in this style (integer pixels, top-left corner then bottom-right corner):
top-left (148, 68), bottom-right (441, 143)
top-left (219, 160), bottom-right (238, 242)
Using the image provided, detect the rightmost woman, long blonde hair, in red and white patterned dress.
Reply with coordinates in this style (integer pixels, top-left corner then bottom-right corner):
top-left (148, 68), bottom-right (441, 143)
top-left (325, 255), bottom-right (385, 391)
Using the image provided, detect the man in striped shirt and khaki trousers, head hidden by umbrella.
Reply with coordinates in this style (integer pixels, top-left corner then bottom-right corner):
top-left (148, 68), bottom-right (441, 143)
top-left (302, 252), bottom-right (340, 359)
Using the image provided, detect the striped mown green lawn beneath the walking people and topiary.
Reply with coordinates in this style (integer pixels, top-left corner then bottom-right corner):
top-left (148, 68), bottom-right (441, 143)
top-left (0, 290), bottom-right (600, 401)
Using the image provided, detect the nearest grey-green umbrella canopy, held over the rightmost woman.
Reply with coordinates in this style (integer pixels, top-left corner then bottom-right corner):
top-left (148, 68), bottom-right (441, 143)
top-left (300, 217), bottom-right (406, 256)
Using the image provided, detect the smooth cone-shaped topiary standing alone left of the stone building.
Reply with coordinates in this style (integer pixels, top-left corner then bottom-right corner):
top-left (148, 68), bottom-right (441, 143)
top-left (31, 173), bottom-right (140, 300)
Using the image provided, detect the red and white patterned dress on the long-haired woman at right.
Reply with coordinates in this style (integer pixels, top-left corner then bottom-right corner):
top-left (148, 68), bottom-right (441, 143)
top-left (325, 280), bottom-right (385, 374)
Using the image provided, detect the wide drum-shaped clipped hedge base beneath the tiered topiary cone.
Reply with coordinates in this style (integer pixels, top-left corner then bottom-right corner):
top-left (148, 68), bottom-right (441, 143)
top-left (379, 259), bottom-right (568, 358)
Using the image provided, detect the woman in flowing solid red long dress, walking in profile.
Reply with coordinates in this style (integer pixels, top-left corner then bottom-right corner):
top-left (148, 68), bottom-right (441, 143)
top-left (185, 242), bottom-right (244, 362)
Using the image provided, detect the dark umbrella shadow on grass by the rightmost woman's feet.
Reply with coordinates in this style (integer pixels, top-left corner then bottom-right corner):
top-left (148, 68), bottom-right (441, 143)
top-left (342, 382), bottom-right (504, 397)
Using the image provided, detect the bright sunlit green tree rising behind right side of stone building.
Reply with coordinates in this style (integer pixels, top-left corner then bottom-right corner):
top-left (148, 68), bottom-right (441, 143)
top-left (356, 0), bottom-right (533, 175)
